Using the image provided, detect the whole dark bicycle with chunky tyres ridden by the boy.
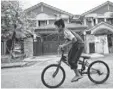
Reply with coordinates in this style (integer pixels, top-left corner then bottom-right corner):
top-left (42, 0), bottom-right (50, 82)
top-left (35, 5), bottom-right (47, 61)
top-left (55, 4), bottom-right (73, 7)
top-left (41, 49), bottom-right (110, 88)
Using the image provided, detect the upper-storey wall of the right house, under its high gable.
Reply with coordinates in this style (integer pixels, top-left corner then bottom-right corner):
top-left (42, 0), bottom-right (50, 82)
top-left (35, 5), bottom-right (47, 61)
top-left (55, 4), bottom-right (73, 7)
top-left (84, 4), bottom-right (113, 28)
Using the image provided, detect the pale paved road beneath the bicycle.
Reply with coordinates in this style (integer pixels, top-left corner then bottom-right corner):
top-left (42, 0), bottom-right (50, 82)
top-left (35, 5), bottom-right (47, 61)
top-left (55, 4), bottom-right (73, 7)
top-left (1, 55), bottom-right (113, 88)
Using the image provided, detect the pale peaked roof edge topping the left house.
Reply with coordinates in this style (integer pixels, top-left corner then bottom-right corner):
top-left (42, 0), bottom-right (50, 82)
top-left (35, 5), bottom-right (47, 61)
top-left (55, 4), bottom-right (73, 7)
top-left (24, 2), bottom-right (73, 16)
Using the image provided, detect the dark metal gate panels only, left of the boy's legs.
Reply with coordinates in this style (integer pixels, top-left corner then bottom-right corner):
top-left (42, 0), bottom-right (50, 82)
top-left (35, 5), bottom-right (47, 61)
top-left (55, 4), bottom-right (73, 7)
top-left (33, 40), bottom-right (70, 56)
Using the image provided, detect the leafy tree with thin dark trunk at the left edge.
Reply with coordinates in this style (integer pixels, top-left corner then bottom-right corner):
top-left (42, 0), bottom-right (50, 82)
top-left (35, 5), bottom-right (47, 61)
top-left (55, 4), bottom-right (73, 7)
top-left (1, 1), bottom-right (33, 57)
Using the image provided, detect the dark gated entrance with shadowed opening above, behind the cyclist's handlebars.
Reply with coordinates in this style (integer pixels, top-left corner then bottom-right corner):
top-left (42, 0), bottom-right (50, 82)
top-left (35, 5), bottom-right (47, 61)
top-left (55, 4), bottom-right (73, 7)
top-left (33, 34), bottom-right (68, 56)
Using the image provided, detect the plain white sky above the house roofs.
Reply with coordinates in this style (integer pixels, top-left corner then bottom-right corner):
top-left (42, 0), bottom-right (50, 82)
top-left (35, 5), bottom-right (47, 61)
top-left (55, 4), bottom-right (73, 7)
top-left (4, 0), bottom-right (113, 15)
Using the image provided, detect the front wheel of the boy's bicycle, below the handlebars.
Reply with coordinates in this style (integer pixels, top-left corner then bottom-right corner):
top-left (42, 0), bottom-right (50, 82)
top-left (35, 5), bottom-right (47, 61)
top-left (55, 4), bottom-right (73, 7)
top-left (41, 64), bottom-right (65, 88)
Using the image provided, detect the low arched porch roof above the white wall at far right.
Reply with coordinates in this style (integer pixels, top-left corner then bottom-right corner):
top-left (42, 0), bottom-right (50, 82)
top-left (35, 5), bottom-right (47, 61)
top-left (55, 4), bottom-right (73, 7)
top-left (89, 22), bottom-right (113, 34)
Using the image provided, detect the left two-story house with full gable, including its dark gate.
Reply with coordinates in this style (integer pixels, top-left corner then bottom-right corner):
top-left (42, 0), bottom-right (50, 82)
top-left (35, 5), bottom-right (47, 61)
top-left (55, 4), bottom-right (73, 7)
top-left (25, 2), bottom-right (87, 55)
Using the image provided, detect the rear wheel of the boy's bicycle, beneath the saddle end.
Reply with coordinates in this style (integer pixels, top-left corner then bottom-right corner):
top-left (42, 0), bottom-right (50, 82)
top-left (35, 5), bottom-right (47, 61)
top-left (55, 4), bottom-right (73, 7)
top-left (88, 61), bottom-right (110, 84)
